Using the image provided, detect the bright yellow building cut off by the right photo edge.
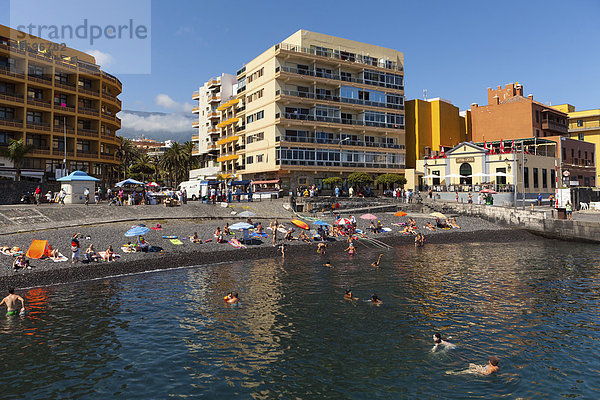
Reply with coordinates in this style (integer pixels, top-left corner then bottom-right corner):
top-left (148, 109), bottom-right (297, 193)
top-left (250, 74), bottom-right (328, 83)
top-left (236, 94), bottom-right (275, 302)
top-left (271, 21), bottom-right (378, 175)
top-left (553, 104), bottom-right (600, 186)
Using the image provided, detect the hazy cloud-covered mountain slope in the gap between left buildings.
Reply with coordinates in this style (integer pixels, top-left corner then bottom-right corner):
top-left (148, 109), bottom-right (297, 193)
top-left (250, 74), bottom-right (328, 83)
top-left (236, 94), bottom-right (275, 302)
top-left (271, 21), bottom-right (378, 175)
top-left (117, 110), bottom-right (198, 143)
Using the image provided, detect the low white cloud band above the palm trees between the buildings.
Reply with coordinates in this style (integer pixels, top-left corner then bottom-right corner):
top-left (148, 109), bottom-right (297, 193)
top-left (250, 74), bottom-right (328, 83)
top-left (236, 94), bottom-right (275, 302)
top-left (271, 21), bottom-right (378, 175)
top-left (119, 111), bottom-right (197, 133)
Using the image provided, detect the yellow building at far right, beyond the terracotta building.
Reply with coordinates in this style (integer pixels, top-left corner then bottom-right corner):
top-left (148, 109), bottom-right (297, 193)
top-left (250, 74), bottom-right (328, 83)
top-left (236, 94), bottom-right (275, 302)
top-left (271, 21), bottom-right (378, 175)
top-left (553, 104), bottom-right (600, 186)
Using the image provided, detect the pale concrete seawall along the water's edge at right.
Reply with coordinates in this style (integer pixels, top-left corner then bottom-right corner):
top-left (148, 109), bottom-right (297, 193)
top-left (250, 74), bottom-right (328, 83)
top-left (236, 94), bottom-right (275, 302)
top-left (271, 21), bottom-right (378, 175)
top-left (427, 202), bottom-right (600, 243)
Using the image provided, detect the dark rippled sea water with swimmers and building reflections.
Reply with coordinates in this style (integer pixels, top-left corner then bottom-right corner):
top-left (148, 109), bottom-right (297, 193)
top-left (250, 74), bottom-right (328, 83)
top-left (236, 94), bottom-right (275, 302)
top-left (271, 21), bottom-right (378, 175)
top-left (0, 240), bottom-right (600, 399)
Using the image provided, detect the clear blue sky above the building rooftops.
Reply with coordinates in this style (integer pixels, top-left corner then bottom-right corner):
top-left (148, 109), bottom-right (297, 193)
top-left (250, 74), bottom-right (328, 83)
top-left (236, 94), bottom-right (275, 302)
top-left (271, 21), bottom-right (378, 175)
top-left (0, 0), bottom-right (600, 138)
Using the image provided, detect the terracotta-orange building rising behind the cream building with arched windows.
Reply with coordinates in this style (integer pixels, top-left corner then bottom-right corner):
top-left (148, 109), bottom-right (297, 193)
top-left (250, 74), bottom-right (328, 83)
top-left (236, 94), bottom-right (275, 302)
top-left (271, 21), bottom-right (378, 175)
top-left (471, 83), bottom-right (596, 186)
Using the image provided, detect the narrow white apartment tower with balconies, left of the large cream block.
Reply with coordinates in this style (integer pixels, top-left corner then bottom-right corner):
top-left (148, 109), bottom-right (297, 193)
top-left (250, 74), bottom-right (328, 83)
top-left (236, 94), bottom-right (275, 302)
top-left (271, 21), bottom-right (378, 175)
top-left (190, 74), bottom-right (237, 179)
